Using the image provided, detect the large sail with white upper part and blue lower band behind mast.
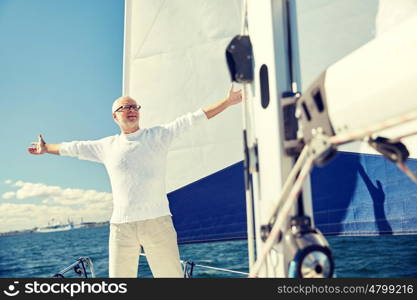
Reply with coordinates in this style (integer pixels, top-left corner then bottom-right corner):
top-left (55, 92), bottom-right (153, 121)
top-left (123, 0), bottom-right (417, 243)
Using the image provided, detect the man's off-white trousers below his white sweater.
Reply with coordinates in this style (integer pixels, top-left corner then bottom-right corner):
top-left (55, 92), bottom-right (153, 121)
top-left (109, 216), bottom-right (183, 278)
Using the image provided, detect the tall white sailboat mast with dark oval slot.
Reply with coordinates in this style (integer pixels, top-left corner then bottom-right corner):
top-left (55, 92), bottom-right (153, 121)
top-left (242, 0), bottom-right (311, 277)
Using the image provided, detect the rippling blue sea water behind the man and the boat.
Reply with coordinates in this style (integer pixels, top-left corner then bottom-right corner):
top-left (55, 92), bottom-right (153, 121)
top-left (0, 226), bottom-right (417, 278)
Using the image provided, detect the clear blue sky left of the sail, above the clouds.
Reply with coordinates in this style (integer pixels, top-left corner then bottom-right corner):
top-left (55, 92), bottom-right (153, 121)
top-left (0, 0), bottom-right (124, 232)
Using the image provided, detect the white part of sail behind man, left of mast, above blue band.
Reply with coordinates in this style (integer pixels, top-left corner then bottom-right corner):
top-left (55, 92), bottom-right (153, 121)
top-left (123, 0), bottom-right (243, 192)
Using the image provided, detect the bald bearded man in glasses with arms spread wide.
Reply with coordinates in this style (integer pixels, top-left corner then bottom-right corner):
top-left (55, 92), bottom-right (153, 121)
top-left (29, 85), bottom-right (242, 277)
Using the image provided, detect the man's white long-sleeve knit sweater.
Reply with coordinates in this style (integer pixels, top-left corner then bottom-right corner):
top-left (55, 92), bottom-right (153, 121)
top-left (59, 109), bottom-right (207, 223)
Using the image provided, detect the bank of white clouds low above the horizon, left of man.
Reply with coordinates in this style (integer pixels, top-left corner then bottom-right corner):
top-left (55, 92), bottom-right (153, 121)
top-left (0, 181), bottom-right (112, 232)
